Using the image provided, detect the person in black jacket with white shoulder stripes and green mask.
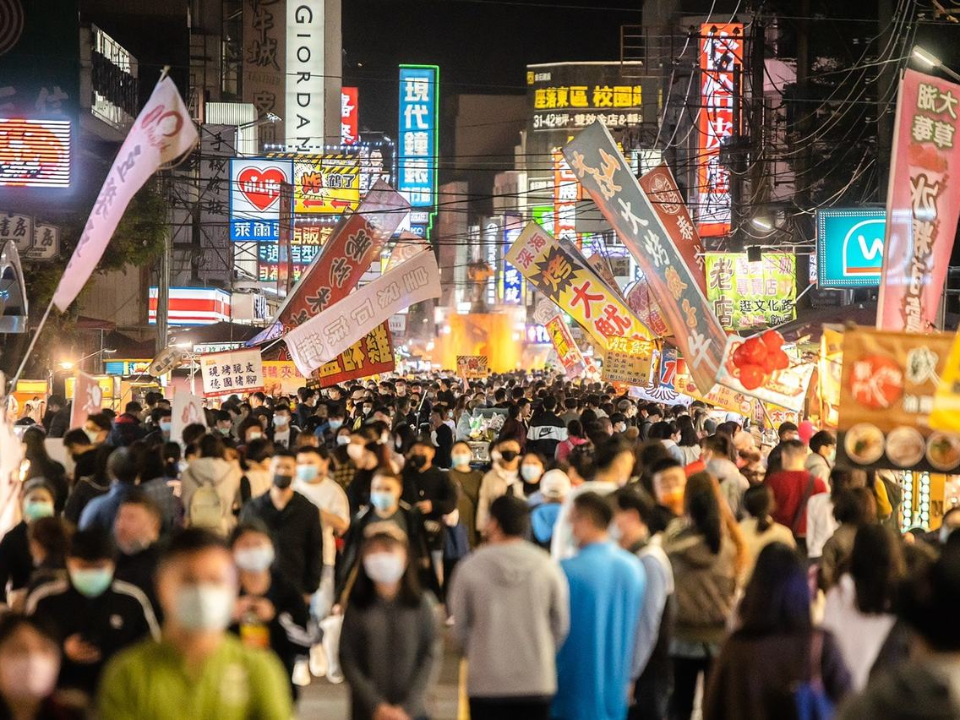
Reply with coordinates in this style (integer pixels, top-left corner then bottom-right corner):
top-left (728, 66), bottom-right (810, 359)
top-left (26, 528), bottom-right (160, 697)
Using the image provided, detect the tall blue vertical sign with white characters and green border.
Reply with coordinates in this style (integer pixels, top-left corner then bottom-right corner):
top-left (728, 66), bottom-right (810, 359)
top-left (397, 65), bottom-right (440, 208)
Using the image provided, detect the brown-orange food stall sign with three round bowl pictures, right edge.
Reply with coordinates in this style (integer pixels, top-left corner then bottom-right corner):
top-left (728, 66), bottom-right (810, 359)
top-left (837, 328), bottom-right (960, 473)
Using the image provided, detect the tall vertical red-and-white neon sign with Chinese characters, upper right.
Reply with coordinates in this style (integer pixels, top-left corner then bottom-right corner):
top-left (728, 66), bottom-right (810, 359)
top-left (697, 23), bottom-right (743, 237)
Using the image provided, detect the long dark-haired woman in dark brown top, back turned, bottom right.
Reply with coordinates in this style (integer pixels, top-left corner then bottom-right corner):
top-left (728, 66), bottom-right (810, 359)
top-left (703, 542), bottom-right (850, 720)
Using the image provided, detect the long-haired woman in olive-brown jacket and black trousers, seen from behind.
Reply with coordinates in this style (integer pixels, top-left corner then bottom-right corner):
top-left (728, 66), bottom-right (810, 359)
top-left (663, 473), bottom-right (743, 720)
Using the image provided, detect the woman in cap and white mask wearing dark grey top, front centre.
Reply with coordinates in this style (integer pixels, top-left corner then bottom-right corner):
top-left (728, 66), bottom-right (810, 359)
top-left (340, 525), bottom-right (443, 720)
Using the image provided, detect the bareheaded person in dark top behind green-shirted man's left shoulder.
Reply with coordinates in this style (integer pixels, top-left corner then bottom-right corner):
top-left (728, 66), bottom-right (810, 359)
top-left (113, 491), bottom-right (163, 614)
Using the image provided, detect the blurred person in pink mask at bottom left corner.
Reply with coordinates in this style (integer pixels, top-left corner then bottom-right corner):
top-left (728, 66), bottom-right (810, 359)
top-left (0, 613), bottom-right (85, 720)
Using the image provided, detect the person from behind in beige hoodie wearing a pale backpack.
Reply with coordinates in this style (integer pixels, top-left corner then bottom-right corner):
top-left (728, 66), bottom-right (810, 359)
top-left (180, 435), bottom-right (241, 538)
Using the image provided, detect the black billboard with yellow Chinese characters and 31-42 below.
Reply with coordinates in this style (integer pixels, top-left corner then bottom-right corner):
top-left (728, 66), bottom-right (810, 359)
top-left (527, 63), bottom-right (643, 132)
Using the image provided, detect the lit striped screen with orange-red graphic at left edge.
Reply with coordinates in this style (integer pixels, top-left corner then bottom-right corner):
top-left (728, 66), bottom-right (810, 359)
top-left (0, 118), bottom-right (73, 188)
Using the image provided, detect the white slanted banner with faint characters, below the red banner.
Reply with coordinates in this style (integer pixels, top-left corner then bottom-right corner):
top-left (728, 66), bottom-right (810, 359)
top-left (283, 250), bottom-right (440, 376)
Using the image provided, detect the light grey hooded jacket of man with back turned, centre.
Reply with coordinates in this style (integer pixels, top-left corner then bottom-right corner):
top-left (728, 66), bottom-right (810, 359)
top-left (447, 541), bottom-right (570, 697)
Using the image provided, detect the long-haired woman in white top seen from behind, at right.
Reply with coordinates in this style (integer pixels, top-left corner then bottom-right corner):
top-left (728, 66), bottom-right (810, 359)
top-left (823, 525), bottom-right (905, 691)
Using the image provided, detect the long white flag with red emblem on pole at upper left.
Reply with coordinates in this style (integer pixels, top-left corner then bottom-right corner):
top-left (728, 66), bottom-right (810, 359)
top-left (53, 78), bottom-right (197, 312)
